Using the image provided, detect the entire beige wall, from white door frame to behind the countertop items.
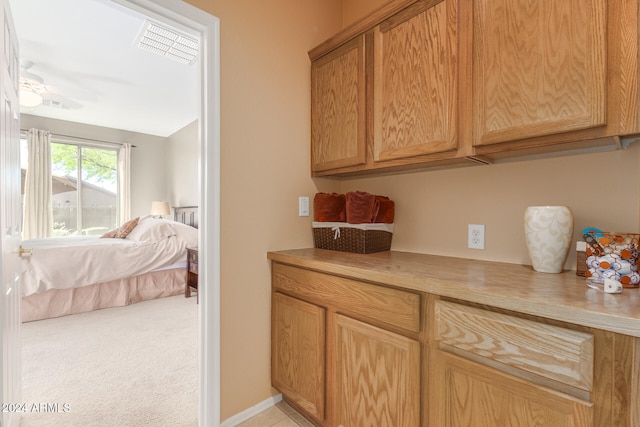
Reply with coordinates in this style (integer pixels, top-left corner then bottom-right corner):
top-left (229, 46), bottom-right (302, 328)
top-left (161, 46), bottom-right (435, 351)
top-left (188, 0), bottom-right (640, 420)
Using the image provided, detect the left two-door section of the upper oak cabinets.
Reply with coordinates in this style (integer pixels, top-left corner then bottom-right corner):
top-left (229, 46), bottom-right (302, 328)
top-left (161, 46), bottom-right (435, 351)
top-left (311, 0), bottom-right (464, 176)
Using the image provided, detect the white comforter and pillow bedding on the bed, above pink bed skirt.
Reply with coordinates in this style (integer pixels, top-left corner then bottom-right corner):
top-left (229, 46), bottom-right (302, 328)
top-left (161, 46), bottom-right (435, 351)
top-left (22, 217), bottom-right (198, 296)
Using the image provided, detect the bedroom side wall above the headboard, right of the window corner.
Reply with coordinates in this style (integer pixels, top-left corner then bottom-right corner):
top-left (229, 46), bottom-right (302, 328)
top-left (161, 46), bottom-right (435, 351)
top-left (166, 120), bottom-right (200, 206)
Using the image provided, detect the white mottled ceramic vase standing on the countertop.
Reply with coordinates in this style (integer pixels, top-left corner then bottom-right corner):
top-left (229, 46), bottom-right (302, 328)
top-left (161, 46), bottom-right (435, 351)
top-left (524, 206), bottom-right (573, 273)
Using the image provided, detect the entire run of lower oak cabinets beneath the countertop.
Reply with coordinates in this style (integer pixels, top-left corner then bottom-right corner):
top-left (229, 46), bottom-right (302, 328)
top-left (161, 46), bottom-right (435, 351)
top-left (272, 262), bottom-right (640, 427)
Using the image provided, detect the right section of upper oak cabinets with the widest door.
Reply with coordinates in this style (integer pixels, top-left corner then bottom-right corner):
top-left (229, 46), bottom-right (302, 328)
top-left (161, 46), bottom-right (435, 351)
top-left (465, 0), bottom-right (640, 158)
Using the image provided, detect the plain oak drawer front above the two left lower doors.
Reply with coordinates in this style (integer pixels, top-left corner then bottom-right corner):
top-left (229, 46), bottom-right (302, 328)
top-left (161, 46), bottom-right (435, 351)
top-left (273, 263), bottom-right (420, 332)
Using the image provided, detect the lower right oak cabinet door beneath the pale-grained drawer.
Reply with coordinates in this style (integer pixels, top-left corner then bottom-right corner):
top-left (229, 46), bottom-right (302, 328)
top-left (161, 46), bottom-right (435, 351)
top-left (429, 352), bottom-right (593, 427)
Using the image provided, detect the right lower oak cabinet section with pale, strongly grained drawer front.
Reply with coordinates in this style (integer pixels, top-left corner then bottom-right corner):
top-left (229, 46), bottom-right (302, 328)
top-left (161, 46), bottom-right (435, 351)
top-left (425, 297), bottom-right (640, 427)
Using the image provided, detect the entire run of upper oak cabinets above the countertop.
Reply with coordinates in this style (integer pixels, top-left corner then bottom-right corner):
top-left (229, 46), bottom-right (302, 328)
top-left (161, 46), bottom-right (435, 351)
top-left (309, 0), bottom-right (640, 176)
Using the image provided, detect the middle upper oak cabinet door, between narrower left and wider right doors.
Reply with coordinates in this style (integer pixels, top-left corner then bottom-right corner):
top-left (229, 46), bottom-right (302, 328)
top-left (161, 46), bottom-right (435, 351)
top-left (373, 0), bottom-right (458, 161)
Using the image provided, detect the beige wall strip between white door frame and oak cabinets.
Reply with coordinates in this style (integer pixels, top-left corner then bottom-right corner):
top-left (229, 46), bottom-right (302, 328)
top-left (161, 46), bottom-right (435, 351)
top-left (188, 0), bottom-right (342, 419)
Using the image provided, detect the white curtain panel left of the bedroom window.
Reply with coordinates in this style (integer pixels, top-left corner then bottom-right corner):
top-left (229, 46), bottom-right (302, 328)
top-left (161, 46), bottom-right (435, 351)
top-left (22, 129), bottom-right (53, 239)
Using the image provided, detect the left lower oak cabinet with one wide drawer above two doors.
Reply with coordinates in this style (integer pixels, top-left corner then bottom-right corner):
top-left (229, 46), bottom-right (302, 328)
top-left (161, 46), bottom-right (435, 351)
top-left (271, 264), bottom-right (422, 427)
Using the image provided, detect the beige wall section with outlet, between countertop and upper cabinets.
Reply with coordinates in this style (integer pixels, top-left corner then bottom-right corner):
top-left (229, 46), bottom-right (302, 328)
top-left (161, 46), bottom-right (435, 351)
top-left (341, 143), bottom-right (640, 270)
